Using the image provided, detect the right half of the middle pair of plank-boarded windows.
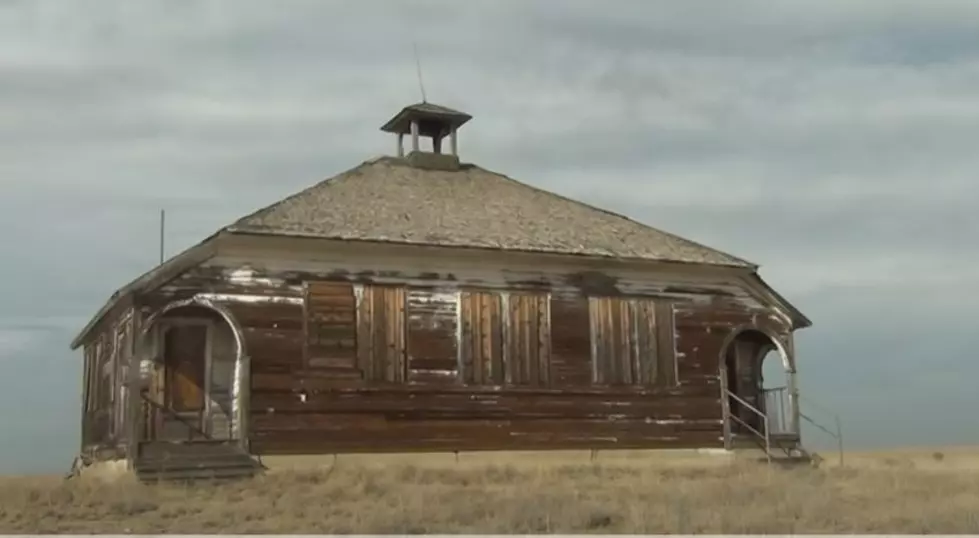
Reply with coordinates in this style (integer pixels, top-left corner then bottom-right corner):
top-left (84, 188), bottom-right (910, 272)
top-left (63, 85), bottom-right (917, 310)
top-left (503, 293), bottom-right (551, 386)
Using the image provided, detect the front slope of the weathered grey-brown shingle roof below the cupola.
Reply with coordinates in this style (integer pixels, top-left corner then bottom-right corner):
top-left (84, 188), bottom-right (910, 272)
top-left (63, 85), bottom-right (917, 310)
top-left (228, 157), bottom-right (754, 267)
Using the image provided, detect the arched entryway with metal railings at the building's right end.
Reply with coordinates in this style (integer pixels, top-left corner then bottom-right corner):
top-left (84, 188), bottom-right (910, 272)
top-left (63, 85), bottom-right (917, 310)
top-left (722, 329), bottom-right (798, 435)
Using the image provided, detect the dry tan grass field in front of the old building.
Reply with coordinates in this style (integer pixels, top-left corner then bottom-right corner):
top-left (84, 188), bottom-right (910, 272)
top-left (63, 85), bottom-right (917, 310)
top-left (0, 449), bottom-right (979, 533)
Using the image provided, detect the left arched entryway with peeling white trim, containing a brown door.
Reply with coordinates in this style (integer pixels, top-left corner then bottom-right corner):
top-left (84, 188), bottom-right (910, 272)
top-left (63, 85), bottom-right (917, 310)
top-left (139, 299), bottom-right (244, 441)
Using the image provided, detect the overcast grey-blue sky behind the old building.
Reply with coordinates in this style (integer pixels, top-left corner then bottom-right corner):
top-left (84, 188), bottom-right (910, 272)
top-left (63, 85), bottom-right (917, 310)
top-left (0, 0), bottom-right (979, 472)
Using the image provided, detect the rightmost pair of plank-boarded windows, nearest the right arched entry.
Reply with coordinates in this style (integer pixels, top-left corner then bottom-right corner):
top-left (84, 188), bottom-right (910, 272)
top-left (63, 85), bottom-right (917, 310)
top-left (589, 297), bottom-right (673, 385)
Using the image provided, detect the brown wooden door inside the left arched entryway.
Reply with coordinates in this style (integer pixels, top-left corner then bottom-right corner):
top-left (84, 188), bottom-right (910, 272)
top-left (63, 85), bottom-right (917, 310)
top-left (163, 325), bottom-right (207, 413)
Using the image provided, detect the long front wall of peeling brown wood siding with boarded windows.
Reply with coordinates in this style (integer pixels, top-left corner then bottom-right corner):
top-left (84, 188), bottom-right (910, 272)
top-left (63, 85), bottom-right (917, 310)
top-left (136, 241), bottom-right (787, 454)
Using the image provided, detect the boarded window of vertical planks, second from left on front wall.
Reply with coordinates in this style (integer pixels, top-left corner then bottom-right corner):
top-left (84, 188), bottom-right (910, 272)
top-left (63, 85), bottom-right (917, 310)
top-left (357, 285), bottom-right (405, 383)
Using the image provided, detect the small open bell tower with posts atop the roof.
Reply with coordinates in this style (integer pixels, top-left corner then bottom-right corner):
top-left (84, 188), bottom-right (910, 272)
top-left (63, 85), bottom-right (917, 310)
top-left (381, 102), bottom-right (472, 170)
